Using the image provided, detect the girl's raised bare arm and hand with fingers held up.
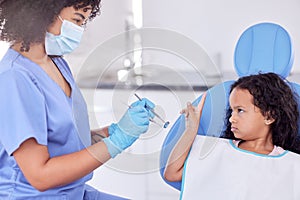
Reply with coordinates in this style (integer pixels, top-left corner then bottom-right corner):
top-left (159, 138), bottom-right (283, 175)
top-left (164, 93), bottom-right (206, 181)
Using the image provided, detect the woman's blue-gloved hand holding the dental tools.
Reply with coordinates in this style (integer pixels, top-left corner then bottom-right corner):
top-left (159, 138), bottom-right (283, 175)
top-left (103, 98), bottom-right (155, 158)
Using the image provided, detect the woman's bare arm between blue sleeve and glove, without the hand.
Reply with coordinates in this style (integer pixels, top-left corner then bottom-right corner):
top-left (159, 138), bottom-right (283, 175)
top-left (13, 138), bottom-right (110, 191)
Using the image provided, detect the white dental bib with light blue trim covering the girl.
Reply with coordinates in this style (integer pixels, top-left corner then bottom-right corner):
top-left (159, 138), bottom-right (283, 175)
top-left (180, 135), bottom-right (300, 200)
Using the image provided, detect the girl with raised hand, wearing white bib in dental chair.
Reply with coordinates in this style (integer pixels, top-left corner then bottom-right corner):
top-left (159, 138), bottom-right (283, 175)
top-left (164, 73), bottom-right (300, 200)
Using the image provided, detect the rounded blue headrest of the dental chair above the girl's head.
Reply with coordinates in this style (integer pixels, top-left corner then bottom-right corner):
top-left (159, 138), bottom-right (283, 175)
top-left (234, 23), bottom-right (293, 78)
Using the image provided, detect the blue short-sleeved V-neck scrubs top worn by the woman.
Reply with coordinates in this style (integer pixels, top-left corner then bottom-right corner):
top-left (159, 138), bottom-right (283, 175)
top-left (0, 49), bottom-right (92, 200)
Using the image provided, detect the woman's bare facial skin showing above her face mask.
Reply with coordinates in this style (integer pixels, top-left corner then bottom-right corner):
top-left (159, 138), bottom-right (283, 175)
top-left (47, 6), bottom-right (92, 35)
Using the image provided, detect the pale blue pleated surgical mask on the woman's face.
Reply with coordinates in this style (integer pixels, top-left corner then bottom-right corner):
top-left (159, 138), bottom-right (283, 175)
top-left (45, 16), bottom-right (84, 56)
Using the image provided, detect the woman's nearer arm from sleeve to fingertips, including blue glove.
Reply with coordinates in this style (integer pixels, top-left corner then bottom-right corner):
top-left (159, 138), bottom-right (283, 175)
top-left (13, 100), bottom-right (154, 191)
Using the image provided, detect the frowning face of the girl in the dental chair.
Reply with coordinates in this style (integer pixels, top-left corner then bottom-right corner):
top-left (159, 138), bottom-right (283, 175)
top-left (229, 88), bottom-right (273, 141)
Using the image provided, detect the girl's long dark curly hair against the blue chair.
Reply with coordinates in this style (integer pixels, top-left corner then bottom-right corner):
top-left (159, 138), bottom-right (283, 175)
top-left (223, 73), bottom-right (300, 153)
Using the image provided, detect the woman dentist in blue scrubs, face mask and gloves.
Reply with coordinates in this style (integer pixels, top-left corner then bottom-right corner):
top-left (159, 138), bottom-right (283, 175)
top-left (0, 0), bottom-right (154, 200)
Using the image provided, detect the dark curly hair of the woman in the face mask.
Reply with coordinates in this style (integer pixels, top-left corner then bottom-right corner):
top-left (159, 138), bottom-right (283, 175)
top-left (0, 0), bottom-right (101, 51)
